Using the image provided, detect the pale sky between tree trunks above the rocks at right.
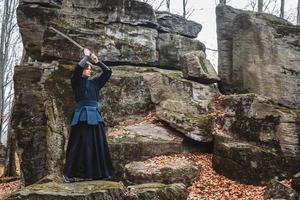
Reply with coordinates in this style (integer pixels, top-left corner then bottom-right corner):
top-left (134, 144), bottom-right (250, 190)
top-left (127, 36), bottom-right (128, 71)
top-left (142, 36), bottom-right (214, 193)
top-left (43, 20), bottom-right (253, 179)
top-left (158, 0), bottom-right (297, 70)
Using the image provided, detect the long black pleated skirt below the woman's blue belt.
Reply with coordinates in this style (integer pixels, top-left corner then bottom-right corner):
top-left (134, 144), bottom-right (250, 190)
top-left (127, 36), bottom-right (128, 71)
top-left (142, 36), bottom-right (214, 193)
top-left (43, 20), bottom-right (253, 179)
top-left (64, 121), bottom-right (114, 180)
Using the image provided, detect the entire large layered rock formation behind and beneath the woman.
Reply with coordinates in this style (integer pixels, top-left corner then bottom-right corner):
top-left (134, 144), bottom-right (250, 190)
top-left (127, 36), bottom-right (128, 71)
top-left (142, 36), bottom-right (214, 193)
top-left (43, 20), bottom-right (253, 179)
top-left (10, 0), bottom-right (219, 195)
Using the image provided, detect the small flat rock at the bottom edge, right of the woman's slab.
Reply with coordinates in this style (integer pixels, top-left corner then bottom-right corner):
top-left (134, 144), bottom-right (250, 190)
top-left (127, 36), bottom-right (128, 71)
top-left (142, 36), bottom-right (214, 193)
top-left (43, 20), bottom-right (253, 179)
top-left (125, 183), bottom-right (188, 200)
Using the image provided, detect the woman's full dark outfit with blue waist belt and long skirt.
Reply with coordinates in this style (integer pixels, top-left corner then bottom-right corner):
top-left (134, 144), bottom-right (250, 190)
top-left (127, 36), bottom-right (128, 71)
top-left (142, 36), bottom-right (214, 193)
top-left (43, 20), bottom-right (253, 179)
top-left (64, 57), bottom-right (114, 180)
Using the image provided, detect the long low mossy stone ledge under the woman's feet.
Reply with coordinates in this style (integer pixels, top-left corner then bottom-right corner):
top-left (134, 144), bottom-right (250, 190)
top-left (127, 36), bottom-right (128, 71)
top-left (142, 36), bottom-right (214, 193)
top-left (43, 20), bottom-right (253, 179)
top-left (6, 174), bottom-right (187, 200)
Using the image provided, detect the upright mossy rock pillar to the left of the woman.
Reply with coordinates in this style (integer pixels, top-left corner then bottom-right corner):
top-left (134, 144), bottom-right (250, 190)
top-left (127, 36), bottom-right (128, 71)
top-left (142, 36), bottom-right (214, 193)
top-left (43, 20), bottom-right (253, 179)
top-left (12, 63), bottom-right (63, 185)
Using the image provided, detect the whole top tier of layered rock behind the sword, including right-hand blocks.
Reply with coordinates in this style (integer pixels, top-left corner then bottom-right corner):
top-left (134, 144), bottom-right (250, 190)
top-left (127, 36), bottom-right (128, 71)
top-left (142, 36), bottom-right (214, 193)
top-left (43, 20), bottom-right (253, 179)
top-left (17, 0), bottom-right (205, 68)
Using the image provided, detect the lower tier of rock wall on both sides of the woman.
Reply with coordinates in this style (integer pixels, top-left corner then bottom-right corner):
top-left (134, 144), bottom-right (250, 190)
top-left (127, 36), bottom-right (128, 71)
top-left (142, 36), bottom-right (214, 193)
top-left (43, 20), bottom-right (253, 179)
top-left (12, 62), bottom-right (217, 185)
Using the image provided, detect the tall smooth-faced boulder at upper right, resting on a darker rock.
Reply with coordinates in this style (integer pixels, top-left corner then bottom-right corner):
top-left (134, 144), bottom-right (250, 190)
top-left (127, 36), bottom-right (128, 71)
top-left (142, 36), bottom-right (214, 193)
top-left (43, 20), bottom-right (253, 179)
top-left (217, 5), bottom-right (300, 109)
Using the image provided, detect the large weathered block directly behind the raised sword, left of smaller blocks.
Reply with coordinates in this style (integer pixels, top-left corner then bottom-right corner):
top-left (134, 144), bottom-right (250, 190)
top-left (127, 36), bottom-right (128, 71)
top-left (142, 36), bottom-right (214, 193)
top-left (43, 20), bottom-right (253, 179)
top-left (17, 0), bottom-right (157, 64)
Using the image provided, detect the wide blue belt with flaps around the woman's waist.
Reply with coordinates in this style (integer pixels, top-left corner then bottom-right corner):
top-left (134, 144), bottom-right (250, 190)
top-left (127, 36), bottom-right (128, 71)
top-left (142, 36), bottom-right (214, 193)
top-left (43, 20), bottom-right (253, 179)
top-left (71, 100), bottom-right (103, 126)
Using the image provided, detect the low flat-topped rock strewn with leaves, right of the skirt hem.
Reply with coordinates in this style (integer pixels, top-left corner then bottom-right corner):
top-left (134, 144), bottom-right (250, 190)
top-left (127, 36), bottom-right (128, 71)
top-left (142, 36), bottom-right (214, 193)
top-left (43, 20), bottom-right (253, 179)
top-left (125, 156), bottom-right (198, 186)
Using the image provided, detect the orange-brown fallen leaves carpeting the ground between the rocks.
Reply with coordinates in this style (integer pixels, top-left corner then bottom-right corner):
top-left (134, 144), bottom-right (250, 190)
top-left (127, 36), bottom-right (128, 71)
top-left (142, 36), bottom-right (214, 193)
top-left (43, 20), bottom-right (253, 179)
top-left (0, 153), bottom-right (290, 200)
